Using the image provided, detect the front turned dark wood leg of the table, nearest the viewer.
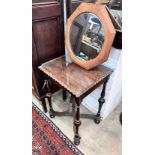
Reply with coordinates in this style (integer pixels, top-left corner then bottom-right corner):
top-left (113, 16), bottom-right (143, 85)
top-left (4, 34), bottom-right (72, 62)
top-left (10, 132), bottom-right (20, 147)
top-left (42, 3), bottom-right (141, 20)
top-left (74, 97), bottom-right (81, 145)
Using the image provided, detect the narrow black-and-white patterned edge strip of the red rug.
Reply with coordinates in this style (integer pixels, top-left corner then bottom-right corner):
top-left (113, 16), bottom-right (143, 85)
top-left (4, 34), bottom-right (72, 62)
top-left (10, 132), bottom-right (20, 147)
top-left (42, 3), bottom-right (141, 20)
top-left (32, 102), bottom-right (84, 155)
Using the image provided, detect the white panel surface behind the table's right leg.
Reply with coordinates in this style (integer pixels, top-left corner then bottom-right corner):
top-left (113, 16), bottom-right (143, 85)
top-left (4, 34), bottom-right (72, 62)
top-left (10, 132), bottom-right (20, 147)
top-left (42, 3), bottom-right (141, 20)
top-left (82, 48), bottom-right (122, 119)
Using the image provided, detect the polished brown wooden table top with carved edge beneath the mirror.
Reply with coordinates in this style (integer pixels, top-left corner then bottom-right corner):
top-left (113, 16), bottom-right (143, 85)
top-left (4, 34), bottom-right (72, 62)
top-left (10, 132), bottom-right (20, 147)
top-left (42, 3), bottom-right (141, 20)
top-left (39, 56), bottom-right (112, 97)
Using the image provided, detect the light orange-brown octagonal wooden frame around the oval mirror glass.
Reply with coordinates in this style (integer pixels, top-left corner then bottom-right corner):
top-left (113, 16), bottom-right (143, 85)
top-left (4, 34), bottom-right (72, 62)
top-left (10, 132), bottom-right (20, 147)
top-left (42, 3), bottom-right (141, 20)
top-left (65, 3), bottom-right (116, 70)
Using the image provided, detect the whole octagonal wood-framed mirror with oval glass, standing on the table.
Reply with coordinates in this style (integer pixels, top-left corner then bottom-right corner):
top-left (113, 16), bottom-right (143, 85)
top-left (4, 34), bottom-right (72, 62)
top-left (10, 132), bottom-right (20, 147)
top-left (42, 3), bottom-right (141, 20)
top-left (66, 3), bottom-right (116, 70)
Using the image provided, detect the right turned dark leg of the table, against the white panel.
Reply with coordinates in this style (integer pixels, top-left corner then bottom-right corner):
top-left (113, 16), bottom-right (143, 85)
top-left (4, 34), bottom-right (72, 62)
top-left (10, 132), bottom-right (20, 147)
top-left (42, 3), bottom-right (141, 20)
top-left (94, 77), bottom-right (108, 124)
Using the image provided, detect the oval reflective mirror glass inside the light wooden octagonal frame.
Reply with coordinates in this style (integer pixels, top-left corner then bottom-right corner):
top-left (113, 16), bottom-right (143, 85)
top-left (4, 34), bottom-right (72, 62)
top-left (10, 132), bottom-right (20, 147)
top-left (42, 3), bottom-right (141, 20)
top-left (70, 13), bottom-right (104, 61)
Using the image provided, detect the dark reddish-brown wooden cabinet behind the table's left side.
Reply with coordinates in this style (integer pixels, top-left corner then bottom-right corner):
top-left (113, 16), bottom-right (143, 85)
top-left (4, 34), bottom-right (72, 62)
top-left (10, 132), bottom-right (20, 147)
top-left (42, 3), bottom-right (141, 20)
top-left (32, 0), bottom-right (65, 99)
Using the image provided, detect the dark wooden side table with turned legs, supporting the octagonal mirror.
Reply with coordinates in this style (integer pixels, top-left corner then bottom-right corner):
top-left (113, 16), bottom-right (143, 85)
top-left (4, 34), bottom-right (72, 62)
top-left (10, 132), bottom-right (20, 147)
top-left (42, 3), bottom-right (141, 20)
top-left (39, 56), bottom-right (112, 145)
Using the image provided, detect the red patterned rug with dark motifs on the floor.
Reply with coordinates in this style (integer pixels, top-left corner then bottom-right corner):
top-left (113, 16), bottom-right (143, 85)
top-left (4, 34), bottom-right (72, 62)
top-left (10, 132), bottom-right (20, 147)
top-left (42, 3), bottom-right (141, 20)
top-left (32, 104), bottom-right (83, 155)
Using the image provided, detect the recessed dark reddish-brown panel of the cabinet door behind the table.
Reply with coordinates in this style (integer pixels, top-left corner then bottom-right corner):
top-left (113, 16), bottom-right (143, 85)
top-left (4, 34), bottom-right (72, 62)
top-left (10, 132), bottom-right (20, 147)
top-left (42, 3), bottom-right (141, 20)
top-left (33, 18), bottom-right (61, 65)
